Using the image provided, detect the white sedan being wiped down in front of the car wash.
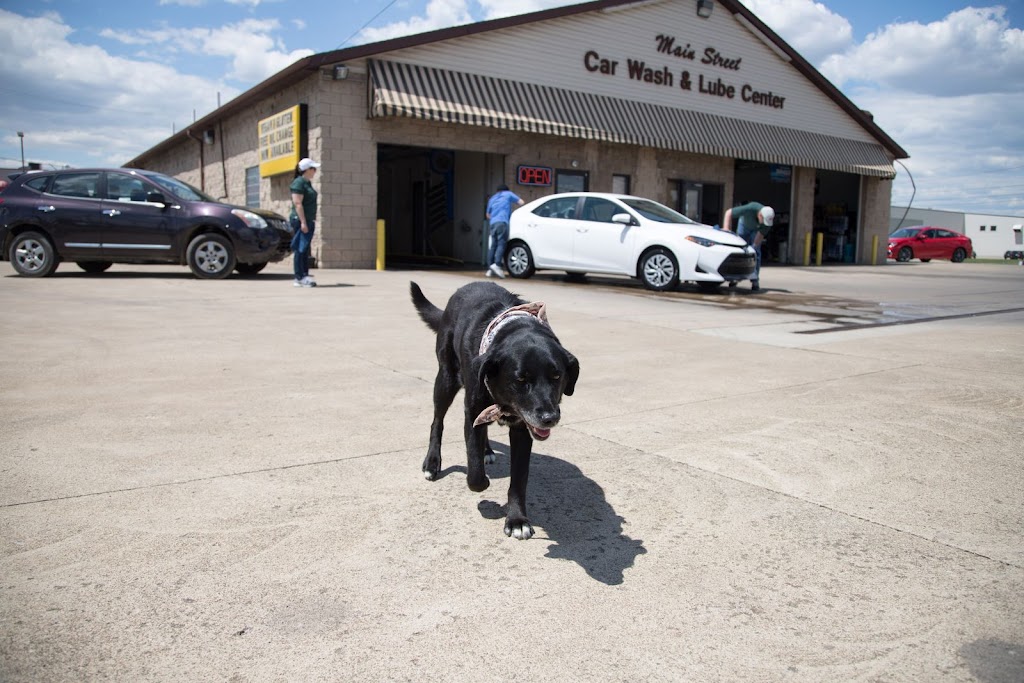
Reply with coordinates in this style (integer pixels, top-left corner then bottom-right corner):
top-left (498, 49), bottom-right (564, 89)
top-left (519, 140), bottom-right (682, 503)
top-left (505, 193), bottom-right (756, 291)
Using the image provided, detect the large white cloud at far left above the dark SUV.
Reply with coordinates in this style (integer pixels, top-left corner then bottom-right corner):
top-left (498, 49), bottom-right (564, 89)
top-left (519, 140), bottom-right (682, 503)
top-left (0, 10), bottom-right (239, 166)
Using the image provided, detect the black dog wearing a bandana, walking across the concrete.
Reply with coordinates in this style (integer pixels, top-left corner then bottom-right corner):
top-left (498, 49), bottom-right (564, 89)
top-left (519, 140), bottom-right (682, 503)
top-left (410, 283), bottom-right (580, 540)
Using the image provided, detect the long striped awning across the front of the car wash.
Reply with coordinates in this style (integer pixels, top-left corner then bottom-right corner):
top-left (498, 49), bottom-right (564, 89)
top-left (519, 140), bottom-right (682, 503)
top-left (369, 59), bottom-right (896, 178)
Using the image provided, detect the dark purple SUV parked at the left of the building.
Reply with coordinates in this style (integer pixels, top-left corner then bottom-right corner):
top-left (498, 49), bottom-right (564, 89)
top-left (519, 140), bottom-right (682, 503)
top-left (0, 168), bottom-right (292, 279)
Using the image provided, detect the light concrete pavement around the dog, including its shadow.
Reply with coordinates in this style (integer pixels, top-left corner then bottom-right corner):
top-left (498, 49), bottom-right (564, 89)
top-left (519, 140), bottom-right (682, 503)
top-left (0, 262), bottom-right (1024, 682)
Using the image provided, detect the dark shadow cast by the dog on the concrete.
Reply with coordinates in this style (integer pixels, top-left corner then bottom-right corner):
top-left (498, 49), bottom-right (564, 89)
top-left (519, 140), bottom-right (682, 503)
top-left (477, 449), bottom-right (647, 586)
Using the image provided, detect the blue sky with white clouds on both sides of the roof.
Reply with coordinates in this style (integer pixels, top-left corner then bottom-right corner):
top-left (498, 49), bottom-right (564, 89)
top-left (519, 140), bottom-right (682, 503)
top-left (0, 0), bottom-right (1024, 216)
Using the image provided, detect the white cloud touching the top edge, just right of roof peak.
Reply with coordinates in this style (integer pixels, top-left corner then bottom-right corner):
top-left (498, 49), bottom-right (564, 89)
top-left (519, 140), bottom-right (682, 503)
top-left (743, 0), bottom-right (853, 63)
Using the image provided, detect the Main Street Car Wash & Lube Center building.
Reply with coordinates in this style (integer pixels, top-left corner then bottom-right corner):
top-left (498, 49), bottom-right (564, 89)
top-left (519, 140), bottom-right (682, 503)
top-left (126, 0), bottom-right (907, 268)
